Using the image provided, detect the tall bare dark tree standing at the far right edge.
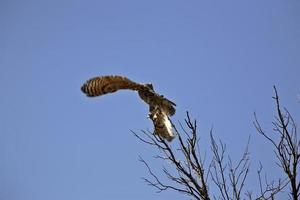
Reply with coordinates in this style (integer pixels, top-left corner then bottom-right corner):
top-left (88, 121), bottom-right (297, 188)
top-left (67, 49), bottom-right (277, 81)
top-left (254, 86), bottom-right (300, 200)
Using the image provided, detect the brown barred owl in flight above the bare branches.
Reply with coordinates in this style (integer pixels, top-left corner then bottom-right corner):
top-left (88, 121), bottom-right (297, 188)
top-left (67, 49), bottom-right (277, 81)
top-left (81, 76), bottom-right (176, 142)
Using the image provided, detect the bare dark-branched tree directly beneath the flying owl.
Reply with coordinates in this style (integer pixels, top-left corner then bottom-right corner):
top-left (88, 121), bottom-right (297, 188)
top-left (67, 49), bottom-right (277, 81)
top-left (133, 114), bottom-right (210, 200)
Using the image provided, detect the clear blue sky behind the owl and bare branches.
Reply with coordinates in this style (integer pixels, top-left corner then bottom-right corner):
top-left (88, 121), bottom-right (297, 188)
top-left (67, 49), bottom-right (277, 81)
top-left (0, 0), bottom-right (300, 200)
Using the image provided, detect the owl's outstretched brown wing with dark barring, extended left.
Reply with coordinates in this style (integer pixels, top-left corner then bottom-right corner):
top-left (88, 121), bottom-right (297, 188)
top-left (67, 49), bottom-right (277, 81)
top-left (81, 76), bottom-right (144, 97)
